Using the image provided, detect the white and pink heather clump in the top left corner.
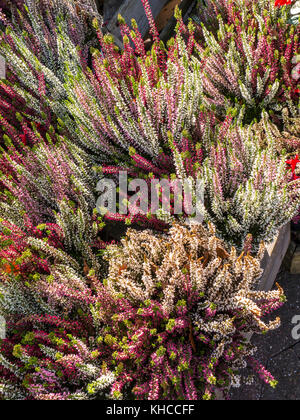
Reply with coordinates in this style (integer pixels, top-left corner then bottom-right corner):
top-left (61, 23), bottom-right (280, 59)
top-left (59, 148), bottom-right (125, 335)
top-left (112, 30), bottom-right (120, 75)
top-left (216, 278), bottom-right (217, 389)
top-left (6, 0), bottom-right (101, 79)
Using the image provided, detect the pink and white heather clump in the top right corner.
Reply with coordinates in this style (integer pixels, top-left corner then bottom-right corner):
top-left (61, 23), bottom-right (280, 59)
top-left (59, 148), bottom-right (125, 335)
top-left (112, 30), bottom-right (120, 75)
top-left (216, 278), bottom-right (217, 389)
top-left (193, 0), bottom-right (299, 125)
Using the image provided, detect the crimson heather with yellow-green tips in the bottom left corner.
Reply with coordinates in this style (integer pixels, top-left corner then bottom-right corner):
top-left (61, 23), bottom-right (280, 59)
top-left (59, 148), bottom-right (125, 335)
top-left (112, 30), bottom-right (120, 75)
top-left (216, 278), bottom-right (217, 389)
top-left (0, 315), bottom-right (115, 400)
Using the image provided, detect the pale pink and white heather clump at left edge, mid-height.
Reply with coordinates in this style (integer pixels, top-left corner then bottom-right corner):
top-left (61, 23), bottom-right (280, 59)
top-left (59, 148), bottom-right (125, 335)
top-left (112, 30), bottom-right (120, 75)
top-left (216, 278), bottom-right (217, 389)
top-left (0, 133), bottom-right (97, 225)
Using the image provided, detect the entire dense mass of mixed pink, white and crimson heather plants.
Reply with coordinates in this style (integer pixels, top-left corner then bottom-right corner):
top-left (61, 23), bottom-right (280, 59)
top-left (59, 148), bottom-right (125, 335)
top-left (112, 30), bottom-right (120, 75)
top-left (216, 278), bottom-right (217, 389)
top-left (0, 0), bottom-right (300, 400)
